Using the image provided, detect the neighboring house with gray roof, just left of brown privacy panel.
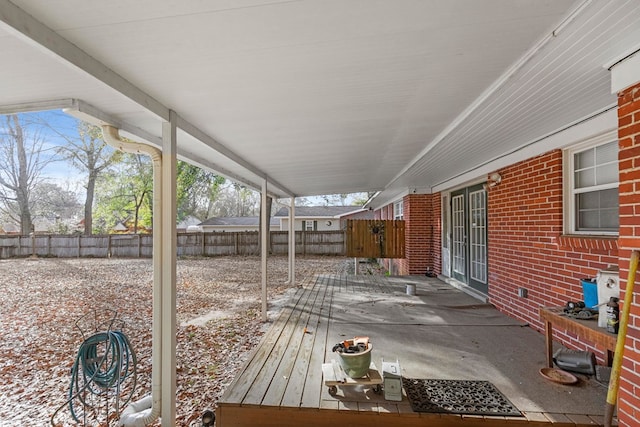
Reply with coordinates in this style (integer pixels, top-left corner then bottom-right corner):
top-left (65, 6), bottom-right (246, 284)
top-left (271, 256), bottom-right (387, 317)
top-left (273, 206), bottom-right (373, 231)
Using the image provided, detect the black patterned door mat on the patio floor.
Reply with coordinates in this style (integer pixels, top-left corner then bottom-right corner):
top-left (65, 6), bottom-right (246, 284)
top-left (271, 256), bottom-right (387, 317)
top-left (402, 378), bottom-right (522, 417)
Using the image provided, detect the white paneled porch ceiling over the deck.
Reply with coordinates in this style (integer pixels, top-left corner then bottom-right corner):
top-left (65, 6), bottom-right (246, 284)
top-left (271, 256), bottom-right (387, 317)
top-left (0, 0), bottom-right (640, 204)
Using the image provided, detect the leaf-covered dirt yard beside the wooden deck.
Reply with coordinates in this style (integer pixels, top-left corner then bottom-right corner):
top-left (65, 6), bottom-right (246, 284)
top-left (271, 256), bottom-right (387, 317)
top-left (0, 257), bottom-right (364, 427)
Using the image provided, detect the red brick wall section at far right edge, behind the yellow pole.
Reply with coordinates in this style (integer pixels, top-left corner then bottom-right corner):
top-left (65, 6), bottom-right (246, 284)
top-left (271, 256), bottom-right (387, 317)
top-left (618, 84), bottom-right (640, 426)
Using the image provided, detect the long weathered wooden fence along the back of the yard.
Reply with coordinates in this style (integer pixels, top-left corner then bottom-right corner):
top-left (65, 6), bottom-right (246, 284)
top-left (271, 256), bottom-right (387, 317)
top-left (0, 231), bottom-right (345, 258)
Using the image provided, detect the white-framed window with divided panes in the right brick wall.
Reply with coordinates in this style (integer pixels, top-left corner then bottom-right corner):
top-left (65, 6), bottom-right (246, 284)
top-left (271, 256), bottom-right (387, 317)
top-left (565, 139), bottom-right (619, 235)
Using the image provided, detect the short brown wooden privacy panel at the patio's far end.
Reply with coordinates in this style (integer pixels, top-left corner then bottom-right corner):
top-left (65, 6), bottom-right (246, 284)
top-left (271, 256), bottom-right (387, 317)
top-left (346, 219), bottom-right (404, 258)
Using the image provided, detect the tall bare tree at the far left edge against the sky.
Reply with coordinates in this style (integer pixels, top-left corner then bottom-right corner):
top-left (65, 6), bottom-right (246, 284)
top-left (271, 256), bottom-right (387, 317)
top-left (0, 114), bottom-right (52, 235)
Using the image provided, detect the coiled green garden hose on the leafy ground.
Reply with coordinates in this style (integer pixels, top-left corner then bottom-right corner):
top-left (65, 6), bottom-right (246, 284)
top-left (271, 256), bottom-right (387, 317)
top-left (51, 331), bottom-right (137, 425)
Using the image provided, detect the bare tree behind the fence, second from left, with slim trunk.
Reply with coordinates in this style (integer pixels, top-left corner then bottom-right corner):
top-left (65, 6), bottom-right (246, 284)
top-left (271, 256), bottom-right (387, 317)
top-left (57, 121), bottom-right (122, 235)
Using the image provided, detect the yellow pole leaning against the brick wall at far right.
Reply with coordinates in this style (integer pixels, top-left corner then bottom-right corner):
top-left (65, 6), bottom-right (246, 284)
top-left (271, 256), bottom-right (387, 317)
top-left (604, 250), bottom-right (640, 427)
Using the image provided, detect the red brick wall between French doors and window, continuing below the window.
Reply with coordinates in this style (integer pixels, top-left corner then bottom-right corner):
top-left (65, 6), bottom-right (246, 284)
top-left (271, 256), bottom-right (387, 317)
top-left (487, 150), bottom-right (618, 360)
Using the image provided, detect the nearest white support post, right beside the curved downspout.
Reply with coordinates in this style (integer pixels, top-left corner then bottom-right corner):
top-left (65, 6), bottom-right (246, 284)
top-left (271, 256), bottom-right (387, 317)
top-left (161, 111), bottom-right (177, 427)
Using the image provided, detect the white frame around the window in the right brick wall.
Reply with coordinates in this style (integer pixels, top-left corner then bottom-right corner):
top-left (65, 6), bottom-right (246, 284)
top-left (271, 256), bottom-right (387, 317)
top-left (562, 131), bottom-right (619, 236)
